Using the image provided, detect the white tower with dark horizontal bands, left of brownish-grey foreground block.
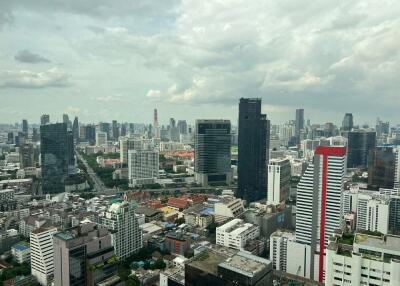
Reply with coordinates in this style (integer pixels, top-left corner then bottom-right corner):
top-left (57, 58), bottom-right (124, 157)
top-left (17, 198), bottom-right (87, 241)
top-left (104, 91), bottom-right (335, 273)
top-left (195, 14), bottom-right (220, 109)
top-left (30, 227), bottom-right (57, 286)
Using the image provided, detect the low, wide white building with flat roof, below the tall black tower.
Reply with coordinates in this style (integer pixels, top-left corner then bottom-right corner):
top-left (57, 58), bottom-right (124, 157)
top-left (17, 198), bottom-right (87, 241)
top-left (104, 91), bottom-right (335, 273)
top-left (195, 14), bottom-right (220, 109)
top-left (216, 219), bottom-right (260, 250)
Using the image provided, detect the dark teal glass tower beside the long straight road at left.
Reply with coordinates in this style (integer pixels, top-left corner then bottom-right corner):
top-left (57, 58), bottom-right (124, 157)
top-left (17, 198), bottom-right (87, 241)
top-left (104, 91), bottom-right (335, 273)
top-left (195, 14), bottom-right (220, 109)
top-left (40, 123), bottom-right (70, 194)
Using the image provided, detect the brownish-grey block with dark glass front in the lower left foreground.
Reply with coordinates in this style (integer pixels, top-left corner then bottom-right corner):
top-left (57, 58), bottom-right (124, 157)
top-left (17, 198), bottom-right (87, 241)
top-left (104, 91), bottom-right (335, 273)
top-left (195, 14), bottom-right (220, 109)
top-left (53, 220), bottom-right (117, 286)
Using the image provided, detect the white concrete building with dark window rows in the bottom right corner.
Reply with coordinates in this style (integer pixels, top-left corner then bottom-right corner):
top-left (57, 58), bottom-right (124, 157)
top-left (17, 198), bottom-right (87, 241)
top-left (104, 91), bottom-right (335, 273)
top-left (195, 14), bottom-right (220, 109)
top-left (325, 233), bottom-right (400, 286)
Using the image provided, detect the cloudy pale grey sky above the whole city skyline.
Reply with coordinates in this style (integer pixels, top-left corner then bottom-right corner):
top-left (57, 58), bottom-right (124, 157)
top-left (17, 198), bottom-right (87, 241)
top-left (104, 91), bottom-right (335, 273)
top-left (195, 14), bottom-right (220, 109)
top-left (0, 0), bottom-right (400, 123)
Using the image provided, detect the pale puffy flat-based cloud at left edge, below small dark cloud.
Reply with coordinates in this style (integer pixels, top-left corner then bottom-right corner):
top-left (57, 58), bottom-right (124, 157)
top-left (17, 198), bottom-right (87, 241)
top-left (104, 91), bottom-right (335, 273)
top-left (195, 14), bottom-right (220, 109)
top-left (0, 68), bottom-right (69, 88)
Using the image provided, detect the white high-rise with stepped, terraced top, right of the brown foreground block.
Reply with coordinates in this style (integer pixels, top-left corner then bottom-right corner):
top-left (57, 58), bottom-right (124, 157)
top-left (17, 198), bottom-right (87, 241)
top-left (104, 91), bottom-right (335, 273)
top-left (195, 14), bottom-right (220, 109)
top-left (101, 202), bottom-right (143, 259)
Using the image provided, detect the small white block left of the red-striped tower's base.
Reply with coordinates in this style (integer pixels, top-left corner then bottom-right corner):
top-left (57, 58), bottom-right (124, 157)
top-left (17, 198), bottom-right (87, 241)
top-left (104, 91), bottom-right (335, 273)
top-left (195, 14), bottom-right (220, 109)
top-left (269, 230), bottom-right (296, 272)
